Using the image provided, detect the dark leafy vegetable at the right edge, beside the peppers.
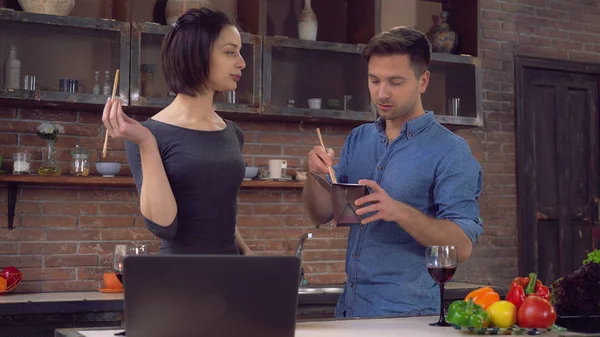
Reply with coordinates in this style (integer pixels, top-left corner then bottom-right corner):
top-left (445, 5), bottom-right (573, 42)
top-left (550, 249), bottom-right (600, 316)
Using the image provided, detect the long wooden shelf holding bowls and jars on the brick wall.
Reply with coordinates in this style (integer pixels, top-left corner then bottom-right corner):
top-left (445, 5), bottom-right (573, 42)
top-left (0, 174), bottom-right (304, 229)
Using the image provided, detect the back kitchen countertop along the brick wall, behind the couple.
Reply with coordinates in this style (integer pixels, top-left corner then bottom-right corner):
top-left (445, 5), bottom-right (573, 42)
top-left (0, 282), bottom-right (507, 316)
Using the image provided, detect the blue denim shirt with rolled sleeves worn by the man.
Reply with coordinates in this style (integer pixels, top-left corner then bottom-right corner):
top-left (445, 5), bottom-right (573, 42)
top-left (334, 112), bottom-right (483, 317)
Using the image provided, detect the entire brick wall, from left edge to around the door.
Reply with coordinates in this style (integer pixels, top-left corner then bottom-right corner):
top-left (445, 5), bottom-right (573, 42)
top-left (0, 0), bottom-right (600, 291)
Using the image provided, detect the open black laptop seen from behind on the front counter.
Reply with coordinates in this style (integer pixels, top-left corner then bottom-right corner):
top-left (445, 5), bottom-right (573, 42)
top-left (123, 255), bottom-right (300, 337)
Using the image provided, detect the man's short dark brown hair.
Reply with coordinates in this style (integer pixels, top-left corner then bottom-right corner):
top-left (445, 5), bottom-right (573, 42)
top-left (363, 27), bottom-right (431, 76)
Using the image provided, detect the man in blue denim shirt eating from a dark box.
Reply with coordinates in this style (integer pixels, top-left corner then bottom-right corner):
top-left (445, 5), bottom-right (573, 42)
top-left (303, 27), bottom-right (482, 317)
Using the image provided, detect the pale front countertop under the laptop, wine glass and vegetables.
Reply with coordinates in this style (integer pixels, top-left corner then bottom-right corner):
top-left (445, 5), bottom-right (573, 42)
top-left (55, 316), bottom-right (600, 337)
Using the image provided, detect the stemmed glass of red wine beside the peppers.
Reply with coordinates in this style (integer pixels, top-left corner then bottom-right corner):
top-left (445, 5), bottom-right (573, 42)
top-left (425, 246), bottom-right (458, 326)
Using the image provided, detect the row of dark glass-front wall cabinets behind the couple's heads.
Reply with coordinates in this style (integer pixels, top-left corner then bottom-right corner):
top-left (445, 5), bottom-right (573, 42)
top-left (0, 5), bottom-right (482, 126)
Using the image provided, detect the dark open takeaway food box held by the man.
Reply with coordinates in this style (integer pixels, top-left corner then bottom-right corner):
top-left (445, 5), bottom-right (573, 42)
top-left (310, 172), bottom-right (370, 226)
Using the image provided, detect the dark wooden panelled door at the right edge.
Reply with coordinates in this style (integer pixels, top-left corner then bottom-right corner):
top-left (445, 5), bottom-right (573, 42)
top-left (515, 55), bottom-right (600, 284)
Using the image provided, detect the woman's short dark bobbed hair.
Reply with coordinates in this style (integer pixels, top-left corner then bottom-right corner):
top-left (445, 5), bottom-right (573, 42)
top-left (161, 7), bottom-right (235, 96)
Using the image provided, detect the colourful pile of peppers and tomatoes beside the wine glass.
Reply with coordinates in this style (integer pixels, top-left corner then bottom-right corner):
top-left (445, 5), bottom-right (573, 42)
top-left (446, 273), bottom-right (557, 329)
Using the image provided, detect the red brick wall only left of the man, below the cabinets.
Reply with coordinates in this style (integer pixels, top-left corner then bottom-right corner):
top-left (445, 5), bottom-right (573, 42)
top-left (0, 108), bottom-right (350, 292)
